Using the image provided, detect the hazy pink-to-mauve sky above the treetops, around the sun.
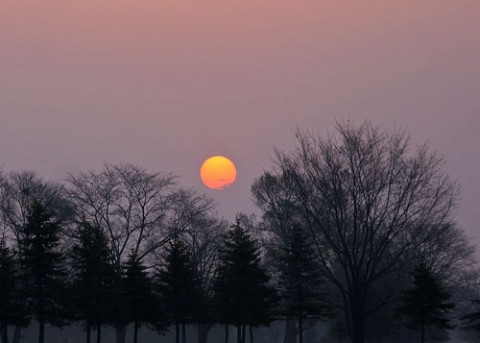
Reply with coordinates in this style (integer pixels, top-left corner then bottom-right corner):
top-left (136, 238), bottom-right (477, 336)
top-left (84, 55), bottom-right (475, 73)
top-left (0, 0), bottom-right (480, 244)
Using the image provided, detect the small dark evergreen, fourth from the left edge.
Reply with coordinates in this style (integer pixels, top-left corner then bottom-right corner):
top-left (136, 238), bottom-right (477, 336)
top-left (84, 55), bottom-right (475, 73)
top-left (123, 254), bottom-right (161, 343)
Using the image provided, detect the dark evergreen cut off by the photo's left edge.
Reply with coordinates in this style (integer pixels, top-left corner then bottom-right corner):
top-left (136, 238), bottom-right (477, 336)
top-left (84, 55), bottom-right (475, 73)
top-left (0, 240), bottom-right (29, 342)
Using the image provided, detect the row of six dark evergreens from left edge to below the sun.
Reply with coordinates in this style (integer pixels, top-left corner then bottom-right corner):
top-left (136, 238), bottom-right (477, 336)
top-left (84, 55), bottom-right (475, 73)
top-left (0, 192), bottom-right (275, 343)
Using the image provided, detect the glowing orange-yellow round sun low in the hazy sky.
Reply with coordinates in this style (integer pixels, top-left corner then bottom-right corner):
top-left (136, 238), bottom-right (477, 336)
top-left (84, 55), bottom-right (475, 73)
top-left (200, 156), bottom-right (237, 189)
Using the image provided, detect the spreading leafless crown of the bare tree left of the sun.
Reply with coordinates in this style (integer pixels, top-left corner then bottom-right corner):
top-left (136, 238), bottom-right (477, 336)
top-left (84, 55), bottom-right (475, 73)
top-left (67, 164), bottom-right (174, 268)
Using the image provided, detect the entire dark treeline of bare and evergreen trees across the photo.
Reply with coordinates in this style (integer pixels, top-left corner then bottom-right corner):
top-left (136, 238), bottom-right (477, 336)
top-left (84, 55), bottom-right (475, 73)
top-left (0, 123), bottom-right (480, 343)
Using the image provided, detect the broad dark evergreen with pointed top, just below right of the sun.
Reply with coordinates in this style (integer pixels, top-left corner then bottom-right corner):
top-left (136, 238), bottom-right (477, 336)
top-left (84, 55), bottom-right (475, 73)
top-left (214, 218), bottom-right (274, 343)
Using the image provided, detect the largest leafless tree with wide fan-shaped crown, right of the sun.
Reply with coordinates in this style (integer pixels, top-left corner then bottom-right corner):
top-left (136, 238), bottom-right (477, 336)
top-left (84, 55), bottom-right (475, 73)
top-left (253, 123), bottom-right (471, 343)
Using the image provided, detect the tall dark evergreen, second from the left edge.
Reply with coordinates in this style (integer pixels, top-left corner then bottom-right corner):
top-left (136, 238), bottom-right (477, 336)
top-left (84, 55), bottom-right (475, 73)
top-left (21, 201), bottom-right (68, 343)
